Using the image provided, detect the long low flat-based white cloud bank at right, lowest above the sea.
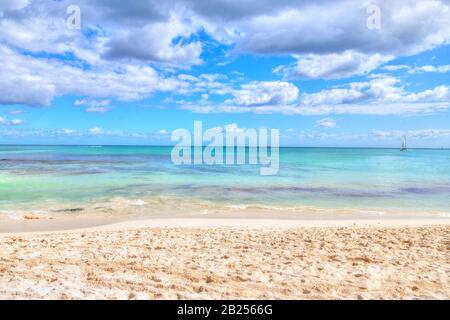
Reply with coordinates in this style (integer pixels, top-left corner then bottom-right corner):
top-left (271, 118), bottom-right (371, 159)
top-left (181, 74), bottom-right (450, 115)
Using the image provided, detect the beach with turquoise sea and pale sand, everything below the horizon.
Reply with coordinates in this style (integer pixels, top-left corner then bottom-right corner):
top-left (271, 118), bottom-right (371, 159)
top-left (0, 146), bottom-right (450, 299)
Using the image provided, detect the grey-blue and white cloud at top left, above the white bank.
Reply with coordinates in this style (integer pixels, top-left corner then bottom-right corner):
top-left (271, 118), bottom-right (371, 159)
top-left (0, 0), bottom-right (201, 65)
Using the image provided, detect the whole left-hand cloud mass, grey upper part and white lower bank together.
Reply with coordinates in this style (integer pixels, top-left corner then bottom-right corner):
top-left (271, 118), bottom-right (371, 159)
top-left (0, 0), bottom-right (201, 107)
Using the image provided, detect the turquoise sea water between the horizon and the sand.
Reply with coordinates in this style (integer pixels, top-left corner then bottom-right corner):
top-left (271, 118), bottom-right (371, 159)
top-left (0, 146), bottom-right (450, 215)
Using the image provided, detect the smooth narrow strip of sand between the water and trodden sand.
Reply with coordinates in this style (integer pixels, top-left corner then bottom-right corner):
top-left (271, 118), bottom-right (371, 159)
top-left (0, 216), bottom-right (450, 237)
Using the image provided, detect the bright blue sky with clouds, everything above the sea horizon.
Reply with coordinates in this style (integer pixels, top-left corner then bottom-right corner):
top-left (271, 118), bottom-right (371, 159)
top-left (0, 0), bottom-right (450, 148)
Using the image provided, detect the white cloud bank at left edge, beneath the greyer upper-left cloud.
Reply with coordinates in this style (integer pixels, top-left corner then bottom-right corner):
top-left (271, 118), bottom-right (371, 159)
top-left (0, 45), bottom-right (180, 106)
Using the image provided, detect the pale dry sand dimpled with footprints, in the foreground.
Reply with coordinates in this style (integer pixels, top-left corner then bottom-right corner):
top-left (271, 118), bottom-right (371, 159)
top-left (0, 219), bottom-right (450, 299)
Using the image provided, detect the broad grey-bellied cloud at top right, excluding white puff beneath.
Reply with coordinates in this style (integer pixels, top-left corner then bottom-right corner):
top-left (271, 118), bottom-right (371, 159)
top-left (227, 0), bottom-right (450, 55)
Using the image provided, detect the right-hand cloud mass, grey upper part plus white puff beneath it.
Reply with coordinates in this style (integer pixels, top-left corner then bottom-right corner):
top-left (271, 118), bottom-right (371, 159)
top-left (232, 0), bottom-right (450, 79)
